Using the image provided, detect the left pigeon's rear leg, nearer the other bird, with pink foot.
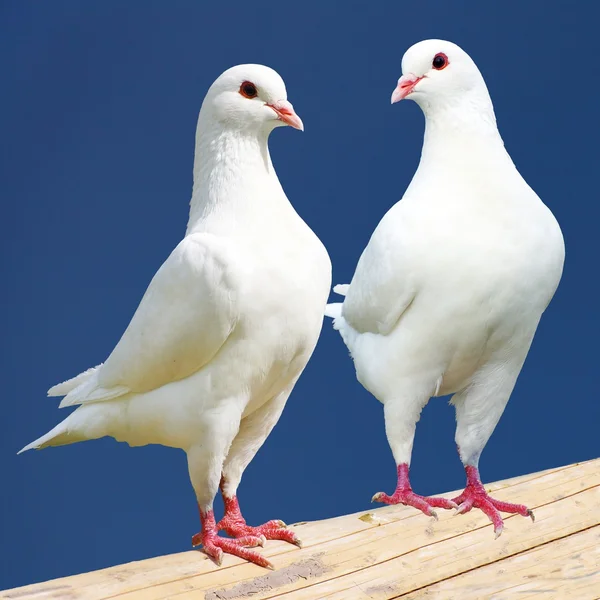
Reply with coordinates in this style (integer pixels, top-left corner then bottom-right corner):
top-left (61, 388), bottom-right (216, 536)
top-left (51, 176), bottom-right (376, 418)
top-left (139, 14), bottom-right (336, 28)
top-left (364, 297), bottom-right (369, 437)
top-left (217, 390), bottom-right (301, 547)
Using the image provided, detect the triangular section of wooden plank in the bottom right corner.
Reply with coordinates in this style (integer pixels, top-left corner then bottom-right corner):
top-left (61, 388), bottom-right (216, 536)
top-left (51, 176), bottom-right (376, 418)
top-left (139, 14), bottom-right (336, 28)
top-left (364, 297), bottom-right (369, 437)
top-left (397, 526), bottom-right (600, 600)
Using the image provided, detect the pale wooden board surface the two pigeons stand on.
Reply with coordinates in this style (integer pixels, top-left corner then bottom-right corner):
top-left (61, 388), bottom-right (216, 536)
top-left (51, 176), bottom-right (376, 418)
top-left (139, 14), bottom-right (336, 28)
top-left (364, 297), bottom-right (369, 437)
top-left (0, 459), bottom-right (600, 600)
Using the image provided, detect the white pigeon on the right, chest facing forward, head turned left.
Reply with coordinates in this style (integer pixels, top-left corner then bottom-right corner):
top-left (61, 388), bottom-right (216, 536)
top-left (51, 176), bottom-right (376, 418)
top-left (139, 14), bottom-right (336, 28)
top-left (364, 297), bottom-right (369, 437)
top-left (326, 40), bottom-right (565, 536)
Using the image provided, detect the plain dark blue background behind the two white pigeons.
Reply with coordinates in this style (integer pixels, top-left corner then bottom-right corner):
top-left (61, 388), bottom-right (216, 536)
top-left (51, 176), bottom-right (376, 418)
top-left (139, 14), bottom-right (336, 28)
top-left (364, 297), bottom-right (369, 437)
top-left (0, 0), bottom-right (600, 588)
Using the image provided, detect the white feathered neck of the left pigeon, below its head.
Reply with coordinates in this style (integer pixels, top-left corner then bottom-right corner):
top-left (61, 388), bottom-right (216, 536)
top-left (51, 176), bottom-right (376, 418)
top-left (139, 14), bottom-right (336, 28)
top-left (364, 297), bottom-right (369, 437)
top-left (187, 123), bottom-right (278, 233)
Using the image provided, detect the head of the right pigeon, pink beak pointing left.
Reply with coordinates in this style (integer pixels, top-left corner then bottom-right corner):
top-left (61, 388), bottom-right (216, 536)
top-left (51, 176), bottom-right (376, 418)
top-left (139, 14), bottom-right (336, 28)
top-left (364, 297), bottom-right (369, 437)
top-left (392, 40), bottom-right (489, 112)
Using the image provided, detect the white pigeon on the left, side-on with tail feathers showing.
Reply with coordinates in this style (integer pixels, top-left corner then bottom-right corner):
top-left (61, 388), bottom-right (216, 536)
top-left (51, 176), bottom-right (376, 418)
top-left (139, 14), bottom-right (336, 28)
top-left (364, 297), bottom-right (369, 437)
top-left (23, 65), bottom-right (331, 567)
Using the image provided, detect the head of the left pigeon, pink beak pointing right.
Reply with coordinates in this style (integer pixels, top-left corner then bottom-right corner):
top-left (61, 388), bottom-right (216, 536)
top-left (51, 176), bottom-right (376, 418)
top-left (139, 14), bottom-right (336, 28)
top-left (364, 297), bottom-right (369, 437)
top-left (202, 64), bottom-right (304, 133)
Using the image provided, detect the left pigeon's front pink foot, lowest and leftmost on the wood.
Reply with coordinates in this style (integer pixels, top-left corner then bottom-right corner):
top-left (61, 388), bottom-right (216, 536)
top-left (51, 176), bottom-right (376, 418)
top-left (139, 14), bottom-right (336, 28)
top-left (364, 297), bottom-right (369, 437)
top-left (192, 510), bottom-right (273, 569)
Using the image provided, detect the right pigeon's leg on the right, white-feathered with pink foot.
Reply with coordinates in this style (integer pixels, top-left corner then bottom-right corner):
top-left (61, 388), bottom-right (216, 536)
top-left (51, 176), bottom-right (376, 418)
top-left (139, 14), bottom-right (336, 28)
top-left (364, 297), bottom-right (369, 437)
top-left (452, 356), bottom-right (534, 538)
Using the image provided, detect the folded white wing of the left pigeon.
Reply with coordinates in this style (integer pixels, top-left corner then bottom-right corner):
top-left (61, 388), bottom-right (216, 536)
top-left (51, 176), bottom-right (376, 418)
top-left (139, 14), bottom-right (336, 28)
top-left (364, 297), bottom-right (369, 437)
top-left (59, 233), bottom-right (241, 407)
